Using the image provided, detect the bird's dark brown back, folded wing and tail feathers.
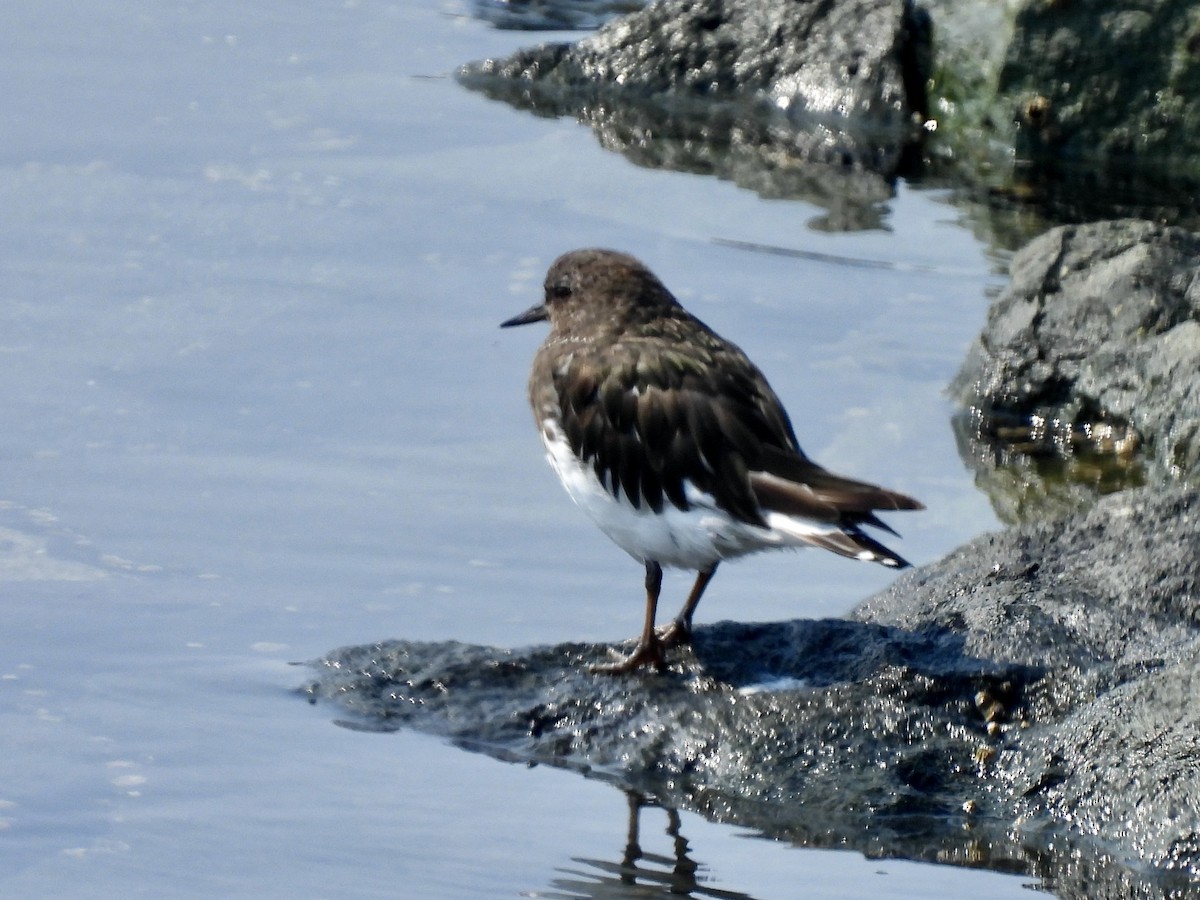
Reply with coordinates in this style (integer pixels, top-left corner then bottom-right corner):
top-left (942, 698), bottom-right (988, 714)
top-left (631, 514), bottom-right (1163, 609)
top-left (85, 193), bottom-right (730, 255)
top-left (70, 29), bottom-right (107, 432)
top-left (540, 318), bottom-right (922, 565)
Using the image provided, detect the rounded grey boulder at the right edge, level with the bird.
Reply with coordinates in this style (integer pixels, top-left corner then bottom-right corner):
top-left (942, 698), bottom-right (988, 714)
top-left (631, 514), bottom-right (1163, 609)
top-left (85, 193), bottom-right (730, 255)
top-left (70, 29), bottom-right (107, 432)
top-left (954, 220), bottom-right (1200, 508)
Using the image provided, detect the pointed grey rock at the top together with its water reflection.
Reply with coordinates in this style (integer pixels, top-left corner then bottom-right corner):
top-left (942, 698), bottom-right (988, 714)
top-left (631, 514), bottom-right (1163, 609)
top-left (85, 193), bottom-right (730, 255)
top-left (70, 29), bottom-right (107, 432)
top-left (458, 0), bottom-right (930, 228)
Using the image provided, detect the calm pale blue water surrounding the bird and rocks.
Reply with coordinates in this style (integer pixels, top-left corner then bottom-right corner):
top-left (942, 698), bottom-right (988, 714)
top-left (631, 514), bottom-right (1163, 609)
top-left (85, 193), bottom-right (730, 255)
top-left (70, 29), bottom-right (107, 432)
top-left (0, 0), bottom-right (1027, 898)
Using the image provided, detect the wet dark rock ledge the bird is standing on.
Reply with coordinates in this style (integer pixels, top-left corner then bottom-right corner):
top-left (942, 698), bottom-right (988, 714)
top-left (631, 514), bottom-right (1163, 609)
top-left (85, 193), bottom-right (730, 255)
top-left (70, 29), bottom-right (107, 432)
top-left (310, 488), bottom-right (1200, 896)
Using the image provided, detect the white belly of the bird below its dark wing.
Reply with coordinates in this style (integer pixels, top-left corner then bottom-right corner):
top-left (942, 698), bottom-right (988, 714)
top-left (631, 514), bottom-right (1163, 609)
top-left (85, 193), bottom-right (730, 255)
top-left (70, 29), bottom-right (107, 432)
top-left (541, 420), bottom-right (833, 570)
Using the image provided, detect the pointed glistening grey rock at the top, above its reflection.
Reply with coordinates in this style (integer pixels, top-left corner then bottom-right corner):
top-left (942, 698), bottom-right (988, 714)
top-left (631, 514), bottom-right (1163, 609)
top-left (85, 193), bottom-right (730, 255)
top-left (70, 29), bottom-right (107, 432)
top-left (464, 0), bottom-right (928, 125)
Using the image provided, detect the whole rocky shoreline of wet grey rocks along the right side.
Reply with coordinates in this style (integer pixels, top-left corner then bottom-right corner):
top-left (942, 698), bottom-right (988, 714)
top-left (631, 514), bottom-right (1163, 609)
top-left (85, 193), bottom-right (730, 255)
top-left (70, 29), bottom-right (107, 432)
top-left (308, 0), bottom-right (1200, 898)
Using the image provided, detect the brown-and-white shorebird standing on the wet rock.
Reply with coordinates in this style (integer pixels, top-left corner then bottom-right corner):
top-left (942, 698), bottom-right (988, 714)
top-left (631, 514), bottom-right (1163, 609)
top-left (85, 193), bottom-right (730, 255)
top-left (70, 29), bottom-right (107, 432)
top-left (500, 248), bottom-right (924, 674)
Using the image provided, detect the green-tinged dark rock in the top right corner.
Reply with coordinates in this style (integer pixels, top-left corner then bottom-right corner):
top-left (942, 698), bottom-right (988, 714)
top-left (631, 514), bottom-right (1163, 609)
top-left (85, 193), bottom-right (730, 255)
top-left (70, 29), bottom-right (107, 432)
top-left (922, 0), bottom-right (1200, 222)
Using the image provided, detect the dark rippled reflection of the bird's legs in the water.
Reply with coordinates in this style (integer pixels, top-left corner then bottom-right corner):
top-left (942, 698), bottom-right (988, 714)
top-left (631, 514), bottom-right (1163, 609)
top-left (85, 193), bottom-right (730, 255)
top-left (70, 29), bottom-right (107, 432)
top-left (540, 791), bottom-right (752, 900)
